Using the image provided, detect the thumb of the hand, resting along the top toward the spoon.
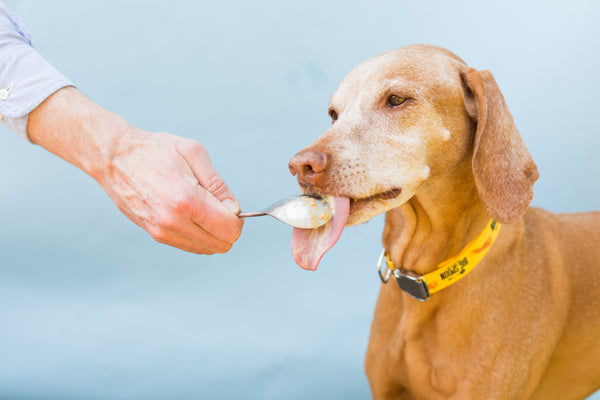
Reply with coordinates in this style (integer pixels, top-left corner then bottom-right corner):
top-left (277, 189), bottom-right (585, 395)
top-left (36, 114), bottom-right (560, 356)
top-left (178, 141), bottom-right (240, 214)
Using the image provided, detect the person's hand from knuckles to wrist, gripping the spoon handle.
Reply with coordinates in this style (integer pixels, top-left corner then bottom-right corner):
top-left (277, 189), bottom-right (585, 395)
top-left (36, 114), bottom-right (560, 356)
top-left (97, 127), bottom-right (243, 254)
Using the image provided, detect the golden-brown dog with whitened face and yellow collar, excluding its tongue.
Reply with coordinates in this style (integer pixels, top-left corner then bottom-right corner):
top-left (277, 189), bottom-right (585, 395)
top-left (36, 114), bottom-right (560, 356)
top-left (289, 45), bottom-right (600, 400)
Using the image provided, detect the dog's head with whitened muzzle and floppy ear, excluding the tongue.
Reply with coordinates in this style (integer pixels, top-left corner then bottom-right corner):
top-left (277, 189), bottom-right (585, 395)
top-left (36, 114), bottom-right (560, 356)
top-left (290, 45), bottom-right (538, 225)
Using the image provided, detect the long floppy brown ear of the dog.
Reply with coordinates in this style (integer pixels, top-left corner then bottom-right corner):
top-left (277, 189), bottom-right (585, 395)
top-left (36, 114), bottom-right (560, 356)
top-left (461, 68), bottom-right (539, 224)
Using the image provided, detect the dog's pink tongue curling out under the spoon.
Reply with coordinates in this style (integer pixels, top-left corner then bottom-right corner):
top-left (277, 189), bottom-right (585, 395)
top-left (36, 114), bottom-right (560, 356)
top-left (292, 197), bottom-right (350, 271)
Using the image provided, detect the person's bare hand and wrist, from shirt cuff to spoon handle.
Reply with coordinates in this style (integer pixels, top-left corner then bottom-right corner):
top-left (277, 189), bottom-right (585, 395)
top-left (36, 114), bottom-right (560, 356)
top-left (28, 88), bottom-right (243, 254)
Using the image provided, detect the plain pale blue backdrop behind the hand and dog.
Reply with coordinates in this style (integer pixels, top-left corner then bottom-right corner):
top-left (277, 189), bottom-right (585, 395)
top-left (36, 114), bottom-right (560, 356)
top-left (0, 0), bottom-right (600, 399)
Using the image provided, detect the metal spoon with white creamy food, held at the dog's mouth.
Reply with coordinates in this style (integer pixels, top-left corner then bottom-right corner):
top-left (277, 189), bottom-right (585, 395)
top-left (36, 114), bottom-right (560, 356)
top-left (237, 195), bottom-right (333, 229)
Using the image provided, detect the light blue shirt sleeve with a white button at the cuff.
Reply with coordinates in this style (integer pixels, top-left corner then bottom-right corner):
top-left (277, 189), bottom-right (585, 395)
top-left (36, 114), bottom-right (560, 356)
top-left (0, 2), bottom-right (73, 139)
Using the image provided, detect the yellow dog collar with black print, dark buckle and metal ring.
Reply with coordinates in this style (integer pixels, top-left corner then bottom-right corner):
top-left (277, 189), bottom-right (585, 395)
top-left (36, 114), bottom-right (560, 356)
top-left (377, 219), bottom-right (501, 301)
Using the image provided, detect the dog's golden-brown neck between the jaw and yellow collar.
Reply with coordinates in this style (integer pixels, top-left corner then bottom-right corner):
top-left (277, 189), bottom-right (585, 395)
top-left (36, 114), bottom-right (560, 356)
top-left (383, 161), bottom-right (490, 275)
